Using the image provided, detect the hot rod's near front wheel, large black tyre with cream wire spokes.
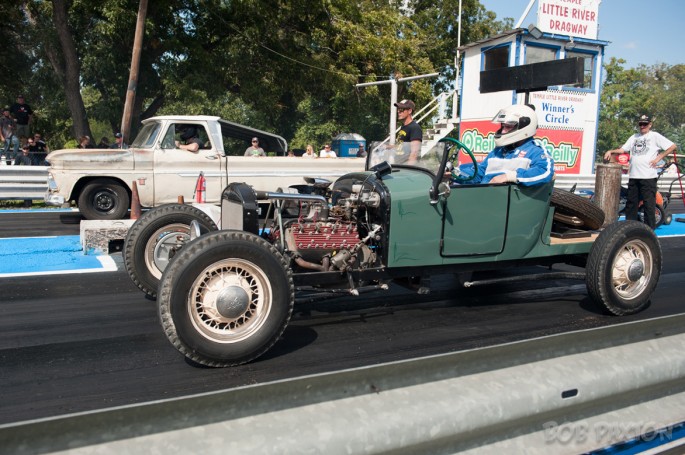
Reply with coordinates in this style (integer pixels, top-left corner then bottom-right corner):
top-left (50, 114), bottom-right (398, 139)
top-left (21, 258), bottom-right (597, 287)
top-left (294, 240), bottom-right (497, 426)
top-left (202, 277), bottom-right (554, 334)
top-left (157, 231), bottom-right (295, 367)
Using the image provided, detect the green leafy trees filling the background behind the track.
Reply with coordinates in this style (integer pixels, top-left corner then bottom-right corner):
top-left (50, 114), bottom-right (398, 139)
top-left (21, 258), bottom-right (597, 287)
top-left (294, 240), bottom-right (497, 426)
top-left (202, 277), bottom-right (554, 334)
top-left (0, 0), bottom-right (685, 159)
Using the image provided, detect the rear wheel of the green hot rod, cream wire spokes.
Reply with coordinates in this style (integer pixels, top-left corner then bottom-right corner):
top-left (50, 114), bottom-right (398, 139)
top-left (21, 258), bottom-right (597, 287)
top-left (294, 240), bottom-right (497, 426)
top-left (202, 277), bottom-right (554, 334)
top-left (585, 221), bottom-right (662, 316)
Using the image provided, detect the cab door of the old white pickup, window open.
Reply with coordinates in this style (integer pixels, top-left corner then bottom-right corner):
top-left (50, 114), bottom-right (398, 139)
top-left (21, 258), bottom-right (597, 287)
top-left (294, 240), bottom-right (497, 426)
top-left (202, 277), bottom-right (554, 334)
top-left (154, 123), bottom-right (223, 204)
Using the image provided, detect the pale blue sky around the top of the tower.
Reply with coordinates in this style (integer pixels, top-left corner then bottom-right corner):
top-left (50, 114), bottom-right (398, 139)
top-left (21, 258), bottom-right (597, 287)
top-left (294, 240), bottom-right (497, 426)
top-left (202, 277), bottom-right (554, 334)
top-left (478, 0), bottom-right (685, 68)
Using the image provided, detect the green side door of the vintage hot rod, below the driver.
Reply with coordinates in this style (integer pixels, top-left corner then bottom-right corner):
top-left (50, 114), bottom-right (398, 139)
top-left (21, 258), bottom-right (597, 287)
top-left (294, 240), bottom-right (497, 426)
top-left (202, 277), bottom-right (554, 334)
top-left (440, 185), bottom-right (511, 257)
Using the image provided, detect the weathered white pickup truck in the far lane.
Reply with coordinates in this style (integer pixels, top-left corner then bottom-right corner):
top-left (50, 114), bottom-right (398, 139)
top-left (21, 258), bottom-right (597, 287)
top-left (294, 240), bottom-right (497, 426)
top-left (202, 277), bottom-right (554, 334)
top-left (45, 116), bottom-right (364, 220)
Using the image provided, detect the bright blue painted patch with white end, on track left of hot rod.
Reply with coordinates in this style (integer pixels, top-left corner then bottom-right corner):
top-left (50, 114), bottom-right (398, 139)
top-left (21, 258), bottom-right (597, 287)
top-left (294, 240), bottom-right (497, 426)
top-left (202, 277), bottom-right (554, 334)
top-left (0, 235), bottom-right (117, 277)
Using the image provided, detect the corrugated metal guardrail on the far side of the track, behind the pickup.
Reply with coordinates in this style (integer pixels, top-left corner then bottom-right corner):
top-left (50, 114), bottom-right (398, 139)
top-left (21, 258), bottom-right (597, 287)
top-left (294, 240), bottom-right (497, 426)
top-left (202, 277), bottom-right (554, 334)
top-left (0, 166), bottom-right (685, 200)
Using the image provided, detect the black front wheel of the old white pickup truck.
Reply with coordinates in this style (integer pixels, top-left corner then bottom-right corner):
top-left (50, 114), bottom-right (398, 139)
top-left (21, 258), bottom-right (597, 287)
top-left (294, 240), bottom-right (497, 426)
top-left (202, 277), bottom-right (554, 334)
top-left (77, 179), bottom-right (131, 220)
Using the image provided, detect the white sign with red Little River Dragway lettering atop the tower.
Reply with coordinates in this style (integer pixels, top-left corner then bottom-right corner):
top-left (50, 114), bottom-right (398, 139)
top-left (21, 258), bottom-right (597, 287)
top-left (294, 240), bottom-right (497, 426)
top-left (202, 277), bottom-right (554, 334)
top-left (537, 0), bottom-right (601, 39)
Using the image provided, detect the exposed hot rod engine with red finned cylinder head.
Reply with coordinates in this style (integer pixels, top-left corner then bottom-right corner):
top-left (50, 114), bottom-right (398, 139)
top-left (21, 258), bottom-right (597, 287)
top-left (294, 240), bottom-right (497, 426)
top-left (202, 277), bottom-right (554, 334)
top-left (270, 183), bottom-right (383, 271)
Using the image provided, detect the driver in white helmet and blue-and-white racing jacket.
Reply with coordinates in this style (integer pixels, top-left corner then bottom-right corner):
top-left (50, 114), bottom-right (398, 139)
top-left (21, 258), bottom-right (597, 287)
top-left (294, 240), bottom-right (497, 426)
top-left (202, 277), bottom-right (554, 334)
top-left (463, 104), bottom-right (554, 186)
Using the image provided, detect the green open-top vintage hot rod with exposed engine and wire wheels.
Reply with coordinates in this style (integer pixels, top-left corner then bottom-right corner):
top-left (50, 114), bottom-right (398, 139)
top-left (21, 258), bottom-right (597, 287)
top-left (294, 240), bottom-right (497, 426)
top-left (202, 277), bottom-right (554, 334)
top-left (124, 139), bottom-right (662, 367)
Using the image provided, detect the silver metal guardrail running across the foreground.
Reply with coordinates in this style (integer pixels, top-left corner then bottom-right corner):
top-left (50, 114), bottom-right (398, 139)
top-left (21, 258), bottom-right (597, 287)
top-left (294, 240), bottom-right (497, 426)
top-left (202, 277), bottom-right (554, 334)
top-left (0, 314), bottom-right (685, 455)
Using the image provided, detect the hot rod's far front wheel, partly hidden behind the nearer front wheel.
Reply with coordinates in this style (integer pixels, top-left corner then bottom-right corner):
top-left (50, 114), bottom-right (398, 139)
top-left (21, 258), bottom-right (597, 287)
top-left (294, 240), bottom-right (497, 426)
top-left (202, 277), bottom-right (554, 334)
top-left (123, 204), bottom-right (217, 299)
